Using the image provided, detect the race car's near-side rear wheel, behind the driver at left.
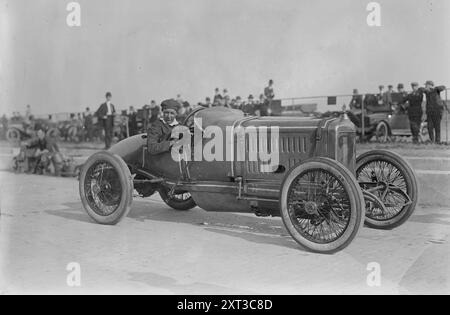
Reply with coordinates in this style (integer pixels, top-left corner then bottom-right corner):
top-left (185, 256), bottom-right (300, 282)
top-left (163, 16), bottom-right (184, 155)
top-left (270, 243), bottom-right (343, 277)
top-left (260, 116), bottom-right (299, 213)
top-left (79, 151), bottom-right (133, 225)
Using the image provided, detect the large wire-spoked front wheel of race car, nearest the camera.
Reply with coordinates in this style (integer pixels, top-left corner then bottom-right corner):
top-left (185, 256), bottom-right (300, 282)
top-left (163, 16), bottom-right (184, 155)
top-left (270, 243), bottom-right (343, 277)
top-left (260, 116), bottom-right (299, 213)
top-left (280, 157), bottom-right (364, 254)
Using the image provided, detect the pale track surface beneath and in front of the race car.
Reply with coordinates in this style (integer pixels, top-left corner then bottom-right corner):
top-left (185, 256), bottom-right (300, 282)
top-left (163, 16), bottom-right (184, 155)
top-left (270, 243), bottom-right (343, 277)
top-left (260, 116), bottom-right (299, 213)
top-left (0, 172), bottom-right (450, 294)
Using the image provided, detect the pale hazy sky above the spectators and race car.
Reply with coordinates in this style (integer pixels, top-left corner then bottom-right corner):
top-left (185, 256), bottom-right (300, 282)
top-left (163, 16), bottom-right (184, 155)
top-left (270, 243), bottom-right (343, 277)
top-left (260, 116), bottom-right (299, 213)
top-left (0, 0), bottom-right (450, 114)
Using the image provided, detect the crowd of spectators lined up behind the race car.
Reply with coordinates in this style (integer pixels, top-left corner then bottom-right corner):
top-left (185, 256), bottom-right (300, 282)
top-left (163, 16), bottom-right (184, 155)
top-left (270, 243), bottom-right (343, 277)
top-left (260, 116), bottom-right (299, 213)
top-left (1, 80), bottom-right (446, 149)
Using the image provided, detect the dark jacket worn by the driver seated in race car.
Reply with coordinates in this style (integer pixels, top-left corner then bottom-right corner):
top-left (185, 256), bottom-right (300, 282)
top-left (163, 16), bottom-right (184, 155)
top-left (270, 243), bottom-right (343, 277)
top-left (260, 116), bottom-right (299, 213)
top-left (147, 119), bottom-right (178, 155)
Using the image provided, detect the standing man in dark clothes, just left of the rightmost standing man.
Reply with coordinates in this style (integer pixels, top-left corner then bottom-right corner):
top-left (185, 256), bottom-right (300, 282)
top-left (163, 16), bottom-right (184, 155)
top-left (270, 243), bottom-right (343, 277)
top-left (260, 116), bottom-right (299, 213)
top-left (404, 82), bottom-right (423, 143)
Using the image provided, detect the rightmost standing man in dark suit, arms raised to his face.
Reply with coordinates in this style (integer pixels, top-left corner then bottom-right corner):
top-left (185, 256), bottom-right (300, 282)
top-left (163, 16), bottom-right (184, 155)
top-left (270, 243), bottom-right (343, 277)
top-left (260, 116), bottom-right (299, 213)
top-left (423, 81), bottom-right (445, 144)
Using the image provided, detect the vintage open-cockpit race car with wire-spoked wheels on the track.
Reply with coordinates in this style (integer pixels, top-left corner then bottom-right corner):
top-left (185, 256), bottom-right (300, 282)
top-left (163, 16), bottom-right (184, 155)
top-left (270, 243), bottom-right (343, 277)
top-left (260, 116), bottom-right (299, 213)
top-left (79, 107), bottom-right (418, 253)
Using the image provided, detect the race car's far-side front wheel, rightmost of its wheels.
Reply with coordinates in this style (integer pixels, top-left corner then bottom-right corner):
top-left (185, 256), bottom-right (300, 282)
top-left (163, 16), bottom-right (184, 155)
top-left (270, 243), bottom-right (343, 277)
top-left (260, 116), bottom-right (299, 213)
top-left (356, 150), bottom-right (419, 230)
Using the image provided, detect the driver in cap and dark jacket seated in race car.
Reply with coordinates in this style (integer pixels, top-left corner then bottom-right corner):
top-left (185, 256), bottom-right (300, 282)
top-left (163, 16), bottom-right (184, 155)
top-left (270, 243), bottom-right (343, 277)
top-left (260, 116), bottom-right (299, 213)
top-left (147, 99), bottom-right (179, 155)
